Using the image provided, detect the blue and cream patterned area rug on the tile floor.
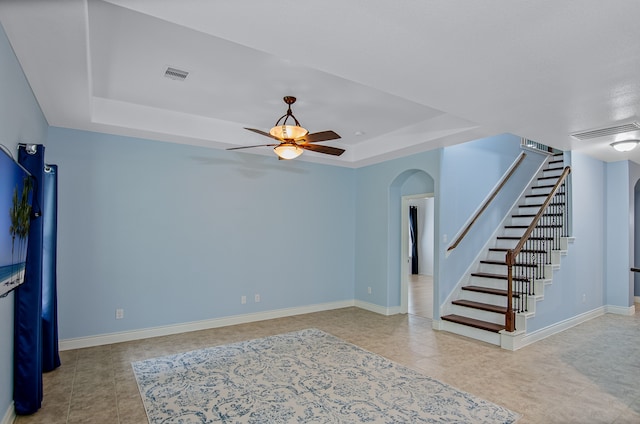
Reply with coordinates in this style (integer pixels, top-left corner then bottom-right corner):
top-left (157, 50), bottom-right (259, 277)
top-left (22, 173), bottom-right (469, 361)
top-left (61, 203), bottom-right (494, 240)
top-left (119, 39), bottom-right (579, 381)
top-left (132, 329), bottom-right (519, 424)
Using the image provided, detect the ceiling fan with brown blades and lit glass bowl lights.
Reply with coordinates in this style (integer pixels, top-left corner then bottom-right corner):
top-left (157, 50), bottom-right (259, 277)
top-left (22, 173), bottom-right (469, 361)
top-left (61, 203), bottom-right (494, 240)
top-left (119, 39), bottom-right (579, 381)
top-left (227, 96), bottom-right (344, 159)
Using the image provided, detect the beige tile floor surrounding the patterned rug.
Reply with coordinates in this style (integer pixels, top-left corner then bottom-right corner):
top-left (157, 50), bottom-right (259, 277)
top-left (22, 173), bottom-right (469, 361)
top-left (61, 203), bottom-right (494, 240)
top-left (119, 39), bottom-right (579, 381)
top-left (16, 305), bottom-right (640, 424)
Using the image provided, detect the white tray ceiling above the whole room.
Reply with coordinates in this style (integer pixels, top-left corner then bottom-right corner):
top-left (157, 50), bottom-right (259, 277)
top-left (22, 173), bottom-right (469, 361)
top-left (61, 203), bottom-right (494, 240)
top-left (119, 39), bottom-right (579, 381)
top-left (0, 0), bottom-right (640, 167)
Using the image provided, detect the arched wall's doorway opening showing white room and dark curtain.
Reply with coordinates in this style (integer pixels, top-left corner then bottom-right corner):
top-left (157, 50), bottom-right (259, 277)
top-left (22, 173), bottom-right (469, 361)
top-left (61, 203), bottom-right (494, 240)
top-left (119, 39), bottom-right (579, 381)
top-left (401, 193), bottom-right (435, 319)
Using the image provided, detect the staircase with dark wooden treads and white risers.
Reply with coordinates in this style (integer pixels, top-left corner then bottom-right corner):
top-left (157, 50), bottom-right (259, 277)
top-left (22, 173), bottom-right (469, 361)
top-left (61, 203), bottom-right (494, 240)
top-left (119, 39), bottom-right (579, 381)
top-left (441, 153), bottom-right (568, 345)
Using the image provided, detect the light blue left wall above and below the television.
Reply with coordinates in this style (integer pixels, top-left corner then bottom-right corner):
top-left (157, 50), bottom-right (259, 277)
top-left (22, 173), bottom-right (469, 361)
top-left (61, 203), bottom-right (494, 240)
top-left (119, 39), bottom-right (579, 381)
top-left (0, 26), bottom-right (47, 418)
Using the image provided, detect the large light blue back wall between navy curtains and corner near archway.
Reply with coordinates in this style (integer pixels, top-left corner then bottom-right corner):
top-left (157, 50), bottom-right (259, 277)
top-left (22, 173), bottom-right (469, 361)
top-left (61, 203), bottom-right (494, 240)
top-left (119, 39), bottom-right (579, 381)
top-left (47, 127), bottom-right (355, 339)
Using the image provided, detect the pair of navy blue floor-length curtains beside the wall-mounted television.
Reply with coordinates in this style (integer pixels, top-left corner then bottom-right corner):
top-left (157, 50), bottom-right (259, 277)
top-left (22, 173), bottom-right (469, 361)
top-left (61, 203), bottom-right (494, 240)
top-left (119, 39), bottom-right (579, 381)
top-left (13, 145), bottom-right (60, 415)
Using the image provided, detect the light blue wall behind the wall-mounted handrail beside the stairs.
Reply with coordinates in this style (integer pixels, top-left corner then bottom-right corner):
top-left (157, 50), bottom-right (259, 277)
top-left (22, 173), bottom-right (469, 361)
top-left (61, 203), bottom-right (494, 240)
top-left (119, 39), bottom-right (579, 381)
top-left (437, 135), bottom-right (547, 312)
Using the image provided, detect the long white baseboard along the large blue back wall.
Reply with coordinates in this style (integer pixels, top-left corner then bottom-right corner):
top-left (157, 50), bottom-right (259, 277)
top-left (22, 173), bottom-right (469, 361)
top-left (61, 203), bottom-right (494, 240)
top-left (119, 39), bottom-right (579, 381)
top-left (60, 300), bottom-right (356, 352)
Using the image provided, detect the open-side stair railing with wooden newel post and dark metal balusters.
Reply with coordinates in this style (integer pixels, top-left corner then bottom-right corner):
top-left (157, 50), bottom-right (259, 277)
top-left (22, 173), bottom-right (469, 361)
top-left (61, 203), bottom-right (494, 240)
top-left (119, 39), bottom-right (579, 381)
top-left (505, 166), bottom-right (571, 332)
